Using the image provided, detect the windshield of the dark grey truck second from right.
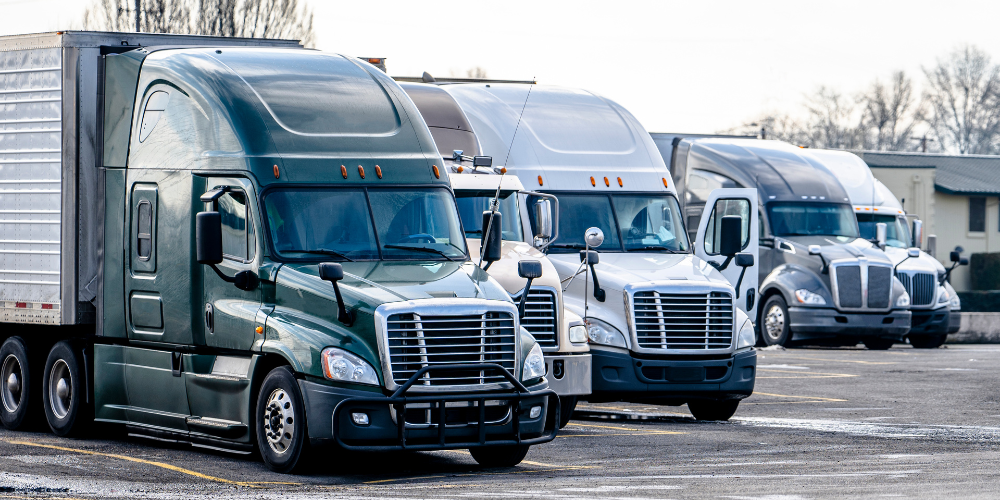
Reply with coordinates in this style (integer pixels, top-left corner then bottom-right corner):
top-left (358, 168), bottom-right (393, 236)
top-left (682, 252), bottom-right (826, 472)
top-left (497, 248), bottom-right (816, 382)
top-left (767, 202), bottom-right (858, 238)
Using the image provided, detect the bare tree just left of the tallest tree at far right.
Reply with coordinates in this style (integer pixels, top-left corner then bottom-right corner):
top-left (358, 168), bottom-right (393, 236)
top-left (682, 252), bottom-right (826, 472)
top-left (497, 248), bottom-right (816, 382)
top-left (860, 71), bottom-right (924, 151)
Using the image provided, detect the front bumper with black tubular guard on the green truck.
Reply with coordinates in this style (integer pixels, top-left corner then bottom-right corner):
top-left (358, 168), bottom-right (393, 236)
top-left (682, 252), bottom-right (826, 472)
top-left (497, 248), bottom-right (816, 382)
top-left (299, 365), bottom-right (559, 451)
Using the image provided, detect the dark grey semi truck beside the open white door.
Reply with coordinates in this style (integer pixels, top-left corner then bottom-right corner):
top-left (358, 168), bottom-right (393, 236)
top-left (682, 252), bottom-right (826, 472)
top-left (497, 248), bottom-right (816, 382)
top-left (671, 138), bottom-right (910, 349)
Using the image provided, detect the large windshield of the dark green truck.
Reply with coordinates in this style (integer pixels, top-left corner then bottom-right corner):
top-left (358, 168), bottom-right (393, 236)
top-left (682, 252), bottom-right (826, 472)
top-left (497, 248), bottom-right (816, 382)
top-left (264, 188), bottom-right (466, 261)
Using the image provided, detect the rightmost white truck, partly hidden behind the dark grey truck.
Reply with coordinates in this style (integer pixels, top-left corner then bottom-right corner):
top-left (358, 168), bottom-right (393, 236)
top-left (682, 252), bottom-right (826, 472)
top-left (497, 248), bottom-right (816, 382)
top-left (810, 146), bottom-right (962, 348)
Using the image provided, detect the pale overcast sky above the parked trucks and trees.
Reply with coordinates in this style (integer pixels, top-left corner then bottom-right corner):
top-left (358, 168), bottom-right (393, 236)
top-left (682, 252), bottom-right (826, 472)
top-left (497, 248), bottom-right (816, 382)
top-left (0, 0), bottom-right (1000, 132)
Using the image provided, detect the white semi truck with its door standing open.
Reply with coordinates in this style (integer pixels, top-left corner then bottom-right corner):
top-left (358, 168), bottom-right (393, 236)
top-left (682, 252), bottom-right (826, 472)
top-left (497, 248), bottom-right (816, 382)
top-left (442, 83), bottom-right (757, 420)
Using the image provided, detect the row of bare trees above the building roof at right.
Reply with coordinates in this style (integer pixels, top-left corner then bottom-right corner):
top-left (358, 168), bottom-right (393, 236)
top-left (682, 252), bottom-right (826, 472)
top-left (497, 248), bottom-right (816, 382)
top-left (723, 45), bottom-right (1000, 154)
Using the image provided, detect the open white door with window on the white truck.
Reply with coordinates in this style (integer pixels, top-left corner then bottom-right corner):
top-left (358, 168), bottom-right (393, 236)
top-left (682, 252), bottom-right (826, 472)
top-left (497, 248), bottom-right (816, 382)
top-left (694, 188), bottom-right (760, 320)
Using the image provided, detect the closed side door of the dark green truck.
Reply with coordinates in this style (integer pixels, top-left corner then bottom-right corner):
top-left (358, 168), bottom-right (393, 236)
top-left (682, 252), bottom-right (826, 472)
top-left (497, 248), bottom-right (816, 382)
top-left (201, 177), bottom-right (261, 355)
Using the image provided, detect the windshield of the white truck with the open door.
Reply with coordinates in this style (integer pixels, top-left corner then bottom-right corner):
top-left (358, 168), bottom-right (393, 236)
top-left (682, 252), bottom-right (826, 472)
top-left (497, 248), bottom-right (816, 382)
top-left (549, 194), bottom-right (688, 252)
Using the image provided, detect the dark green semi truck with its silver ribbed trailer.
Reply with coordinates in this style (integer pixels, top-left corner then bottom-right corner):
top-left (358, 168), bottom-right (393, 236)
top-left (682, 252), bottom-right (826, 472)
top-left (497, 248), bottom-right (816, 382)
top-left (0, 32), bottom-right (559, 472)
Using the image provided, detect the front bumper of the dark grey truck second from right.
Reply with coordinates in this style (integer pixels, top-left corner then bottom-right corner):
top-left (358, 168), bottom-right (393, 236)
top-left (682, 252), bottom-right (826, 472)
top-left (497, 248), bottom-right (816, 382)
top-left (788, 307), bottom-right (911, 341)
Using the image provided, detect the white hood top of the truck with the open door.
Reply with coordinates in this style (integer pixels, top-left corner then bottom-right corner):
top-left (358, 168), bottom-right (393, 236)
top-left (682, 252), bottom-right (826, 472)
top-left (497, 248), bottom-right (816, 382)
top-left (549, 253), bottom-right (729, 290)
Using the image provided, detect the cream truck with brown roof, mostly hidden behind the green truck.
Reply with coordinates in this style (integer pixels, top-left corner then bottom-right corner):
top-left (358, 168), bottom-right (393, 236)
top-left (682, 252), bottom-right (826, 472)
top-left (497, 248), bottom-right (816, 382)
top-left (400, 83), bottom-right (591, 427)
